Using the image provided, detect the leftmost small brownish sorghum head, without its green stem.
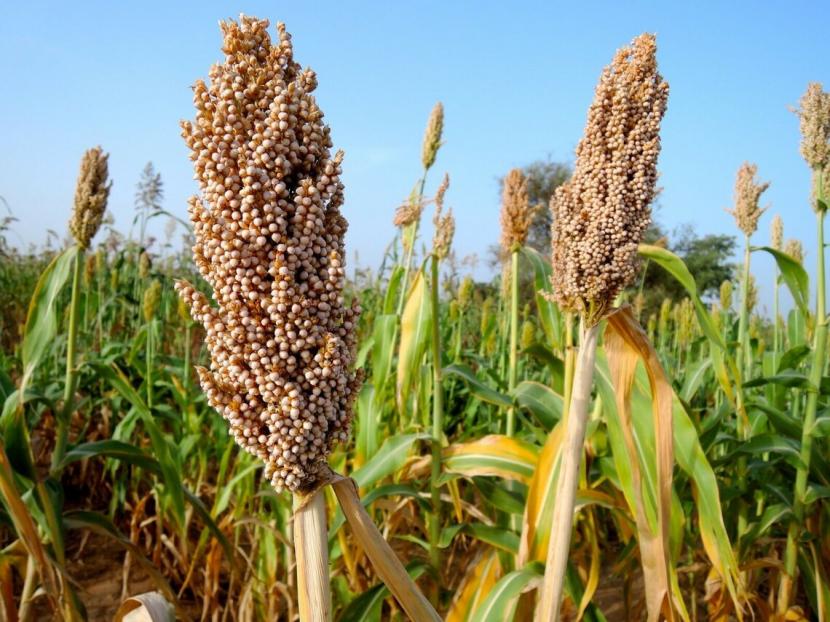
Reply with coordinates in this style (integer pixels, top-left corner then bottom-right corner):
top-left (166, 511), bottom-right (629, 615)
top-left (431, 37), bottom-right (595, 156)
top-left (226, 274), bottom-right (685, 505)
top-left (69, 147), bottom-right (112, 249)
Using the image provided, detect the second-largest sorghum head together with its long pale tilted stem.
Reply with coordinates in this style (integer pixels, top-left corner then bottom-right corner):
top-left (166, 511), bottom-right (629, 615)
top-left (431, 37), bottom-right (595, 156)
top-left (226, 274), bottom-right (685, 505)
top-left (537, 34), bottom-right (668, 622)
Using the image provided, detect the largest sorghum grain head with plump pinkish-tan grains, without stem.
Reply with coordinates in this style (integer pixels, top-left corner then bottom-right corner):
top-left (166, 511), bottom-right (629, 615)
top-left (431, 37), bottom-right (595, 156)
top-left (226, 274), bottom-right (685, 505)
top-left (177, 16), bottom-right (360, 493)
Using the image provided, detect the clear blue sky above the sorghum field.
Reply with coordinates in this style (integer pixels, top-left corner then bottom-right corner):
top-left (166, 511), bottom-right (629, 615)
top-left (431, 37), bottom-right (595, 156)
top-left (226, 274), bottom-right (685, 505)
top-left (0, 0), bottom-right (830, 312)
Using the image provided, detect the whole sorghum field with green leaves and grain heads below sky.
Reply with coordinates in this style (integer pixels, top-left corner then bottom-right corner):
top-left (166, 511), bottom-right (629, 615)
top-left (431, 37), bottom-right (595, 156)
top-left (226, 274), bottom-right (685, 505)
top-left (0, 11), bottom-right (830, 622)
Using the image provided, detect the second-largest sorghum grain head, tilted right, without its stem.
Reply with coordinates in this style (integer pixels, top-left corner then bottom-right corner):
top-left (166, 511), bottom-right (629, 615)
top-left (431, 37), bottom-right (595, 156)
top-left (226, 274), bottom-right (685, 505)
top-left (551, 34), bottom-right (669, 324)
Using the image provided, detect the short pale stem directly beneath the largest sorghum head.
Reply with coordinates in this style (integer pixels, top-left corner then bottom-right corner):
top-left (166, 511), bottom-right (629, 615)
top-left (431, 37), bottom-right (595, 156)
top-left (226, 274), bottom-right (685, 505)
top-left (294, 489), bottom-right (332, 622)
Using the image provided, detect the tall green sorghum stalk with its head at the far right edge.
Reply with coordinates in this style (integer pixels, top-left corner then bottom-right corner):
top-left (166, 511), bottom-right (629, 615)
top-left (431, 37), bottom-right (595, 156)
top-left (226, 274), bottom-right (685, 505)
top-left (778, 83), bottom-right (830, 613)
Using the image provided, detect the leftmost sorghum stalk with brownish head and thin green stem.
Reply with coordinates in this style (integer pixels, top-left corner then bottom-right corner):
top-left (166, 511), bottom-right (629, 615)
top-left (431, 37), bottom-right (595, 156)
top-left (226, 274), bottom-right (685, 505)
top-left (52, 147), bottom-right (112, 469)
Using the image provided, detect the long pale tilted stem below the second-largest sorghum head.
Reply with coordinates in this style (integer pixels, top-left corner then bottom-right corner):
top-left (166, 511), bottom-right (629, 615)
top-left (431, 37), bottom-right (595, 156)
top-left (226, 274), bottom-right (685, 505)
top-left (536, 321), bottom-right (599, 622)
